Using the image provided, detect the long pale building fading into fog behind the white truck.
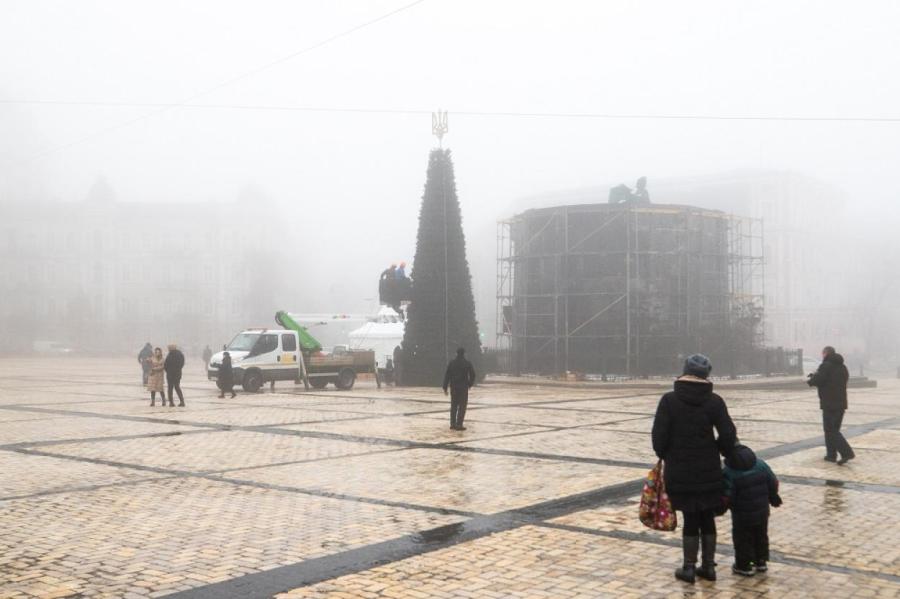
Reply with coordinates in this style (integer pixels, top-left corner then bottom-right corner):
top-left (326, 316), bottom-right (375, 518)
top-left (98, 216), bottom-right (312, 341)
top-left (0, 186), bottom-right (290, 353)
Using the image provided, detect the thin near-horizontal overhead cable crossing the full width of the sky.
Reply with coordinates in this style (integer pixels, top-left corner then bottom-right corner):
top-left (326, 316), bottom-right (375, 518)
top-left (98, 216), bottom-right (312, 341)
top-left (0, 98), bottom-right (900, 123)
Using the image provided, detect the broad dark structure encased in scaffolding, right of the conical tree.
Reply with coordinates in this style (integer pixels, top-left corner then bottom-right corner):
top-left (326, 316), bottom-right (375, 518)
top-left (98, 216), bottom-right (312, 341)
top-left (497, 204), bottom-right (764, 376)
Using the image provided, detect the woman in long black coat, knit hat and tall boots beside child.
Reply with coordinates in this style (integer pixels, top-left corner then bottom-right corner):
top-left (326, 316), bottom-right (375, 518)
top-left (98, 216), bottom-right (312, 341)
top-left (652, 354), bottom-right (737, 584)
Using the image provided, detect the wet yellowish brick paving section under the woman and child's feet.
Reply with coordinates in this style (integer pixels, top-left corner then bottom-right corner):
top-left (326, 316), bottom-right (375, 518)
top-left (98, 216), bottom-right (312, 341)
top-left (279, 526), bottom-right (900, 599)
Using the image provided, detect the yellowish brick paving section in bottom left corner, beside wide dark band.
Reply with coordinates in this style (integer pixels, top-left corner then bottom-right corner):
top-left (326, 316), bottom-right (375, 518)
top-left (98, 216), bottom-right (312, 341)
top-left (0, 478), bottom-right (459, 597)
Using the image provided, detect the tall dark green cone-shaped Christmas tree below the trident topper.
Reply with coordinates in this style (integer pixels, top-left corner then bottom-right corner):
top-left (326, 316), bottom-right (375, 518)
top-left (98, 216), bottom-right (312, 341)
top-left (402, 149), bottom-right (484, 385)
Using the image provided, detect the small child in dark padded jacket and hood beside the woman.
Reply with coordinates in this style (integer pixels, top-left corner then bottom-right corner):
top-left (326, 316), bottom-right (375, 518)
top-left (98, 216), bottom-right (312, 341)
top-left (723, 445), bottom-right (781, 576)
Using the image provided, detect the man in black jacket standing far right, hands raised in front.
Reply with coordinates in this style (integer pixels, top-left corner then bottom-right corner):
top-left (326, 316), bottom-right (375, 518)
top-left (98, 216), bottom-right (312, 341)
top-left (807, 346), bottom-right (856, 465)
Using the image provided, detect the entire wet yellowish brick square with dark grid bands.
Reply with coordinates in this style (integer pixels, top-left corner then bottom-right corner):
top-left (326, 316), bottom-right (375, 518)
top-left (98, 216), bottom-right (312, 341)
top-left (0, 358), bottom-right (900, 599)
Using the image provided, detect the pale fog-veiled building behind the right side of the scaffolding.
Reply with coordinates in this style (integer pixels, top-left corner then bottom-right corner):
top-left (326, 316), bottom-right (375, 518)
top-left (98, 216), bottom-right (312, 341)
top-left (657, 171), bottom-right (863, 355)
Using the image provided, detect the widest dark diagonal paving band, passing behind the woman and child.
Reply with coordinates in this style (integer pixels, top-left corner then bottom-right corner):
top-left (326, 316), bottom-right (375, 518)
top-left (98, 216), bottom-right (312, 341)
top-left (158, 417), bottom-right (900, 599)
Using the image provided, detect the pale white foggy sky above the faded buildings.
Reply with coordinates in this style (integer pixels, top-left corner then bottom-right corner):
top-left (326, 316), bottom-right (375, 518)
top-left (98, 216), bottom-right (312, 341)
top-left (0, 0), bottom-right (900, 328)
